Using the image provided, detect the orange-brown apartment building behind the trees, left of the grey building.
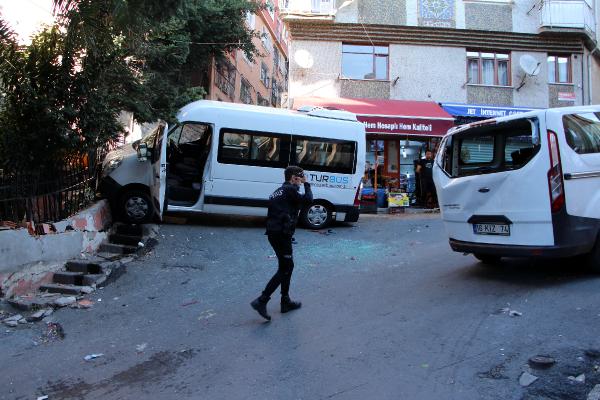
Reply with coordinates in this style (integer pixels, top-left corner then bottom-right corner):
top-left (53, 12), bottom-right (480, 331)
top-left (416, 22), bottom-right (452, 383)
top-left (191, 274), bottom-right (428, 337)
top-left (206, 0), bottom-right (289, 107)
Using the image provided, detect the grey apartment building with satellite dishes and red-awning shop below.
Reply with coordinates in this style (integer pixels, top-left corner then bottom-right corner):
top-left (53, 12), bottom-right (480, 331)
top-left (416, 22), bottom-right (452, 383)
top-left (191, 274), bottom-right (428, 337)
top-left (280, 0), bottom-right (600, 200)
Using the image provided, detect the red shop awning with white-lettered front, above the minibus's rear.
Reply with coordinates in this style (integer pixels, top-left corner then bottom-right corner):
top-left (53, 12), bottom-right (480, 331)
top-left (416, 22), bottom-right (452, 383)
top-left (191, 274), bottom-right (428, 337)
top-left (293, 97), bottom-right (454, 136)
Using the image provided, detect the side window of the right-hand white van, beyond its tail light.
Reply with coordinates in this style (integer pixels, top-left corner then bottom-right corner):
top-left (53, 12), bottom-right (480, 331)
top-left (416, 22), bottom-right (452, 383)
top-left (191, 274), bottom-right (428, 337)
top-left (563, 112), bottom-right (600, 154)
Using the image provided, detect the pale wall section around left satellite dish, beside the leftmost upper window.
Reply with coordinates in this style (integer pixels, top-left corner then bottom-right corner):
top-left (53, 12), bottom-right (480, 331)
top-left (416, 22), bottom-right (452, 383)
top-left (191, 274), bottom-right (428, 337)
top-left (289, 40), bottom-right (342, 98)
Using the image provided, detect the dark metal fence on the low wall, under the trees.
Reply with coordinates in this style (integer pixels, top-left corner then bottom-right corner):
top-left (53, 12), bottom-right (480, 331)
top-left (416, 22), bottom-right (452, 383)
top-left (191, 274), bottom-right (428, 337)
top-left (0, 148), bottom-right (108, 227)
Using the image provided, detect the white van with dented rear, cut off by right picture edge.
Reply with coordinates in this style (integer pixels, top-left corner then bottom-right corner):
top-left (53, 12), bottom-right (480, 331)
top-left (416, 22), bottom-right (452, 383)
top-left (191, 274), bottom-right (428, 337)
top-left (433, 106), bottom-right (600, 269)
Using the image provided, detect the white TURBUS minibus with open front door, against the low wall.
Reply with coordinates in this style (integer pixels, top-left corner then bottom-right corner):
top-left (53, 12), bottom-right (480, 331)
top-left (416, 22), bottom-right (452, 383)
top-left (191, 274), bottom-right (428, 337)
top-left (100, 100), bottom-right (365, 229)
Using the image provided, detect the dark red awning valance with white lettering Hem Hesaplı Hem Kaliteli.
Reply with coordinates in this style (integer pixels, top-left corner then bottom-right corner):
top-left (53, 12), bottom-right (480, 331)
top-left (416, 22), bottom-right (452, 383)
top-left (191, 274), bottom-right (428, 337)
top-left (356, 115), bottom-right (454, 136)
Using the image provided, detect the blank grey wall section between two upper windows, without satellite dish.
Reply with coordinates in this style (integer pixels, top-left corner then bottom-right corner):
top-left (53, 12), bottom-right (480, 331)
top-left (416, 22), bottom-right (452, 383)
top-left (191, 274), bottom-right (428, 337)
top-left (390, 45), bottom-right (466, 103)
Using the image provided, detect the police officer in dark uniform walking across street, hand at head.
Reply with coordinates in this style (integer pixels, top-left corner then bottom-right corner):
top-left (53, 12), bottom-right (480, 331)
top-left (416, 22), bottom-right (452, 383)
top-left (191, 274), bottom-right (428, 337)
top-left (250, 166), bottom-right (313, 321)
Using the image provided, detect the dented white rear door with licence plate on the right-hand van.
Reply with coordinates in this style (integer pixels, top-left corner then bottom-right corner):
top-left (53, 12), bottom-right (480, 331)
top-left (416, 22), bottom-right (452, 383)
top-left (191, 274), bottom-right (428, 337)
top-left (434, 112), bottom-right (554, 246)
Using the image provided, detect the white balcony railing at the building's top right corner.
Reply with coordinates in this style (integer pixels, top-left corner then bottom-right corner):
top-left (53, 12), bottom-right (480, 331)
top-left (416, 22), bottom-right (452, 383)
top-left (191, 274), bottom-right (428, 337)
top-left (540, 0), bottom-right (596, 34)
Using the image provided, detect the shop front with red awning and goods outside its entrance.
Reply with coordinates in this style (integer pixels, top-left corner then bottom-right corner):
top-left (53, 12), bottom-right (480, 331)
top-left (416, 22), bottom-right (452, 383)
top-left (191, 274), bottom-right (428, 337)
top-left (293, 97), bottom-right (454, 209)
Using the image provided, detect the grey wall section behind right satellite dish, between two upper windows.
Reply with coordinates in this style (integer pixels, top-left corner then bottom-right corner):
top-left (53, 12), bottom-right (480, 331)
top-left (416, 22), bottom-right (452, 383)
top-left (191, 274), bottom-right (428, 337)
top-left (511, 51), bottom-right (548, 108)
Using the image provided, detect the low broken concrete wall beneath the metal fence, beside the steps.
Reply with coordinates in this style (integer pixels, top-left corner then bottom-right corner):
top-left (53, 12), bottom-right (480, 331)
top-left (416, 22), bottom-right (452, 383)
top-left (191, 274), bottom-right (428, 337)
top-left (0, 200), bottom-right (111, 295)
